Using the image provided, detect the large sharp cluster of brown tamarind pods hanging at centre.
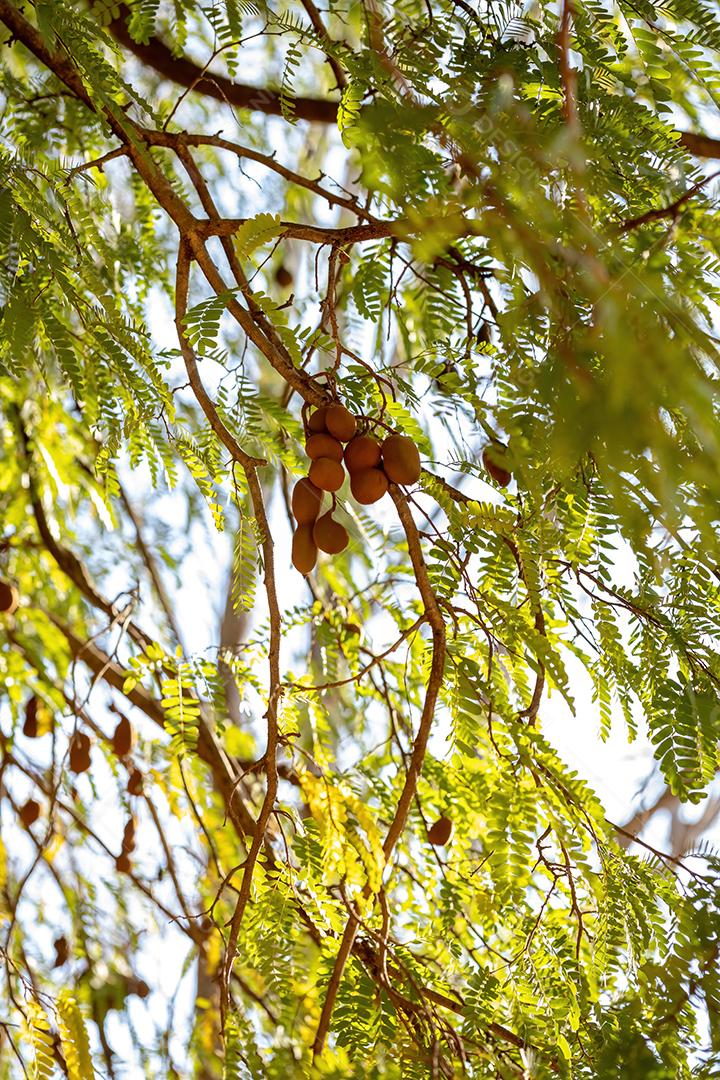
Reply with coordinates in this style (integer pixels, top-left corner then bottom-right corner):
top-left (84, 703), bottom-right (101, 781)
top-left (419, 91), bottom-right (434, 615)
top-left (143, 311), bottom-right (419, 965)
top-left (291, 404), bottom-right (421, 575)
